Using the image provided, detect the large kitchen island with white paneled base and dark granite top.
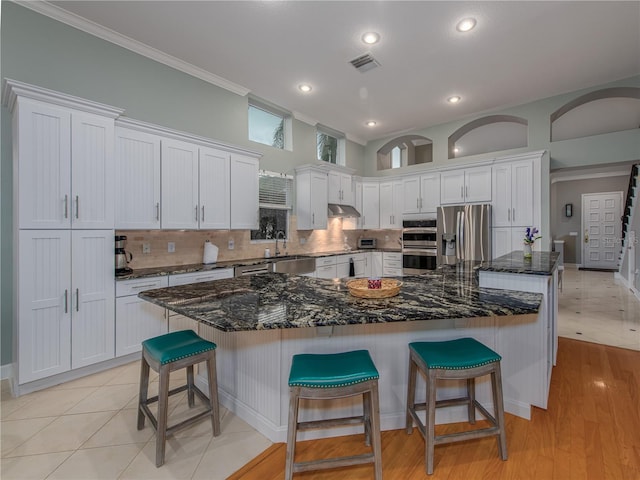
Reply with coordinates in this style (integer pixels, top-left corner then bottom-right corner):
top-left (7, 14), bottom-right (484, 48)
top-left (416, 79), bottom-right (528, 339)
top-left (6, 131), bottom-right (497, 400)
top-left (140, 262), bottom-right (546, 442)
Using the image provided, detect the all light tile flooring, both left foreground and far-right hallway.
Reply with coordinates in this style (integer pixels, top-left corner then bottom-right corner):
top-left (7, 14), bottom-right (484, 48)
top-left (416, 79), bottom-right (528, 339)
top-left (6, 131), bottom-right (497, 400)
top-left (0, 269), bottom-right (640, 480)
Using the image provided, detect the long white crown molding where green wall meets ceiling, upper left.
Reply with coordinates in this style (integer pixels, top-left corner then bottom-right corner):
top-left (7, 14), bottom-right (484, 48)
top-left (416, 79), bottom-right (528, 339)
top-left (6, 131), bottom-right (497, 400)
top-left (11, 0), bottom-right (251, 96)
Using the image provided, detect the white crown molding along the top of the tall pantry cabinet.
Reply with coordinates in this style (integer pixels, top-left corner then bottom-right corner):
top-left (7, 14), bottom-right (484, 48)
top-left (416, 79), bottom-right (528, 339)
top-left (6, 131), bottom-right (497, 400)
top-left (2, 78), bottom-right (124, 118)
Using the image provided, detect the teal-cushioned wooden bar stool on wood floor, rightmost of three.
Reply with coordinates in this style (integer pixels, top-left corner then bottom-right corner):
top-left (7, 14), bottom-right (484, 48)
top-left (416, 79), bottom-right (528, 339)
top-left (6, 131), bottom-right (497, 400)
top-left (406, 338), bottom-right (507, 475)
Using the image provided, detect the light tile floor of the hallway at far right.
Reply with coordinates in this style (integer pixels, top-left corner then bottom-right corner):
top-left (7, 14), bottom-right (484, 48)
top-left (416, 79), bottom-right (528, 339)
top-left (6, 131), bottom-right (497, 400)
top-left (558, 268), bottom-right (640, 350)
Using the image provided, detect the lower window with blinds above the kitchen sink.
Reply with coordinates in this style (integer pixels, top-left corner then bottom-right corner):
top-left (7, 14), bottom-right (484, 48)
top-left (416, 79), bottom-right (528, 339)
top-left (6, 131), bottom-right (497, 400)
top-left (251, 170), bottom-right (293, 240)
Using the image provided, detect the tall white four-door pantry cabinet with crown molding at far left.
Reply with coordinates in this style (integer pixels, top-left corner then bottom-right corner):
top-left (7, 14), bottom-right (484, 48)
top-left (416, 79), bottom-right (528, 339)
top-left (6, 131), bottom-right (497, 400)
top-left (3, 80), bottom-right (122, 391)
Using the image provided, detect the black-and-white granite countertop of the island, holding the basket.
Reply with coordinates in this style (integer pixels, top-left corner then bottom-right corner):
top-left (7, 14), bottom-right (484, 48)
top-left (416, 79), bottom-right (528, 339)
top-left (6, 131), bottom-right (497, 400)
top-left (138, 268), bottom-right (542, 332)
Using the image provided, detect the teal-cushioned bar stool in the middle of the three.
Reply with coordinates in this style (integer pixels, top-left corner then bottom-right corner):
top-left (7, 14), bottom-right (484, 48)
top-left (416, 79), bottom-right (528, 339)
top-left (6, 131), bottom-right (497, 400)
top-left (285, 350), bottom-right (382, 480)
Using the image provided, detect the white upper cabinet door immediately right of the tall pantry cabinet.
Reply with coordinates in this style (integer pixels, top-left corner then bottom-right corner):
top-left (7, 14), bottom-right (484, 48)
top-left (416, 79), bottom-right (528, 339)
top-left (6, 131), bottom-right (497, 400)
top-left (115, 127), bottom-right (160, 230)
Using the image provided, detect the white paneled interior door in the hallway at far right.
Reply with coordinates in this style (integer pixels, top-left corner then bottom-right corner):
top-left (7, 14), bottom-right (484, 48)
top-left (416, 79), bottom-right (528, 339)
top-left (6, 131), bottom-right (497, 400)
top-left (582, 192), bottom-right (622, 269)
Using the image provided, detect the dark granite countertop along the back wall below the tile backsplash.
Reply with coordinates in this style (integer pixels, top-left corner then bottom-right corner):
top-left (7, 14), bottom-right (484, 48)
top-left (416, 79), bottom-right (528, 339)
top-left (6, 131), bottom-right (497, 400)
top-left (116, 248), bottom-right (401, 281)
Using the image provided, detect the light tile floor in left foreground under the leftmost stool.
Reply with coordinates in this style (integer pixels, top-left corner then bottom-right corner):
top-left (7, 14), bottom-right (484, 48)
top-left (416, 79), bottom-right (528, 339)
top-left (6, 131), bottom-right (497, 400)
top-left (0, 362), bottom-right (271, 480)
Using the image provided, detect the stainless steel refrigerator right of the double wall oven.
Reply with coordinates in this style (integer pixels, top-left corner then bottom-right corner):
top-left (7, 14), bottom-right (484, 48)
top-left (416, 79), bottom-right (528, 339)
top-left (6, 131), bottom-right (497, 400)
top-left (436, 205), bottom-right (491, 265)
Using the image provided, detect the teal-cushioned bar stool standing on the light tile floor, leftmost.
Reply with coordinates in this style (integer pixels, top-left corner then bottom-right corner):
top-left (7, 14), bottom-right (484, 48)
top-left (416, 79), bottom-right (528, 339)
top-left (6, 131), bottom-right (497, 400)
top-left (138, 330), bottom-right (220, 467)
